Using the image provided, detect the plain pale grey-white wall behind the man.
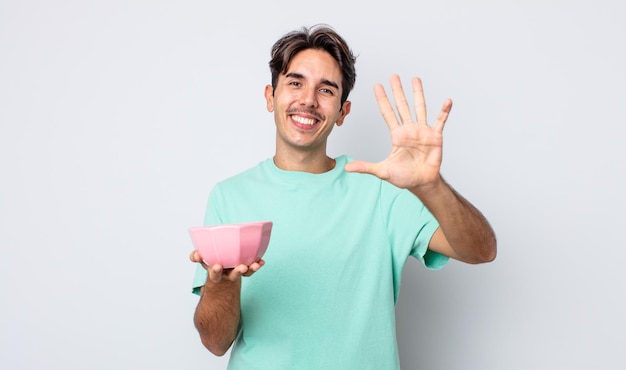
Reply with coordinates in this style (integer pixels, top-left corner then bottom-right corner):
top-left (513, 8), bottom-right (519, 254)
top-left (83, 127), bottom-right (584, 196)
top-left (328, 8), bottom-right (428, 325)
top-left (0, 0), bottom-right (626, 370)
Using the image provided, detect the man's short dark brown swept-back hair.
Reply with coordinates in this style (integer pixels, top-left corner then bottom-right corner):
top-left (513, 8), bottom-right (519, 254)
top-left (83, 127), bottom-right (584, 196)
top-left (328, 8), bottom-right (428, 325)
top-left (269, 25), bottom-right (356, 104)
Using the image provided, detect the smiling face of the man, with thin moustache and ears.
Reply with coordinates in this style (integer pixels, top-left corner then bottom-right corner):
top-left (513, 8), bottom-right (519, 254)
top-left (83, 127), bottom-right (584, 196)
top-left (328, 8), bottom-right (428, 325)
top-left (265, 49), bottom-right (350, 154)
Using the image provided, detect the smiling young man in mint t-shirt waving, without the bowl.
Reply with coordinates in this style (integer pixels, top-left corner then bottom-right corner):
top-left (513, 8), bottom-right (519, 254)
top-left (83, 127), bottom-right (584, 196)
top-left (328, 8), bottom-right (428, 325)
top-left (190, 27), bottom-right (496, 370)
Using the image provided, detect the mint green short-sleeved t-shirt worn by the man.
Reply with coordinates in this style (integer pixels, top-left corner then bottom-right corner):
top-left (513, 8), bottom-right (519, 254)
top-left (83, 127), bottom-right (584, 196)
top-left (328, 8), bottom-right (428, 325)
top-left (193, 156), bottom-right (448, 370)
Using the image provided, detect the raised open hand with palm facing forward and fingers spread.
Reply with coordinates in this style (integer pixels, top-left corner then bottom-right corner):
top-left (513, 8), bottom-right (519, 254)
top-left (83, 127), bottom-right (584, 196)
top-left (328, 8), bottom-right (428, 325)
top-left (345, 75), bottom-right (452, 189)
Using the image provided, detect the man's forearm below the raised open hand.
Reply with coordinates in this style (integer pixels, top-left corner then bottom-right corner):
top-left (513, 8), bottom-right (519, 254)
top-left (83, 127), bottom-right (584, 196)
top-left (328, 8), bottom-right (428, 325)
top-left (411, 178), bottom-right (496, 263)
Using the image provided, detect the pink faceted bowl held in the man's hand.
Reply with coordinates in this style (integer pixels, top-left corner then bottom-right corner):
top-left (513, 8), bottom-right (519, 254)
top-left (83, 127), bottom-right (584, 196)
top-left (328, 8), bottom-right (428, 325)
top-left (189, 221), bottom-right (272, 268)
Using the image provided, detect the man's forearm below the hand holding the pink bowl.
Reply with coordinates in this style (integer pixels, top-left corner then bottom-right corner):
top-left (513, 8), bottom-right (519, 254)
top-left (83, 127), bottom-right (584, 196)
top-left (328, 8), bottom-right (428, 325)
top-left (194, 278), bottom-right (241, 356)
